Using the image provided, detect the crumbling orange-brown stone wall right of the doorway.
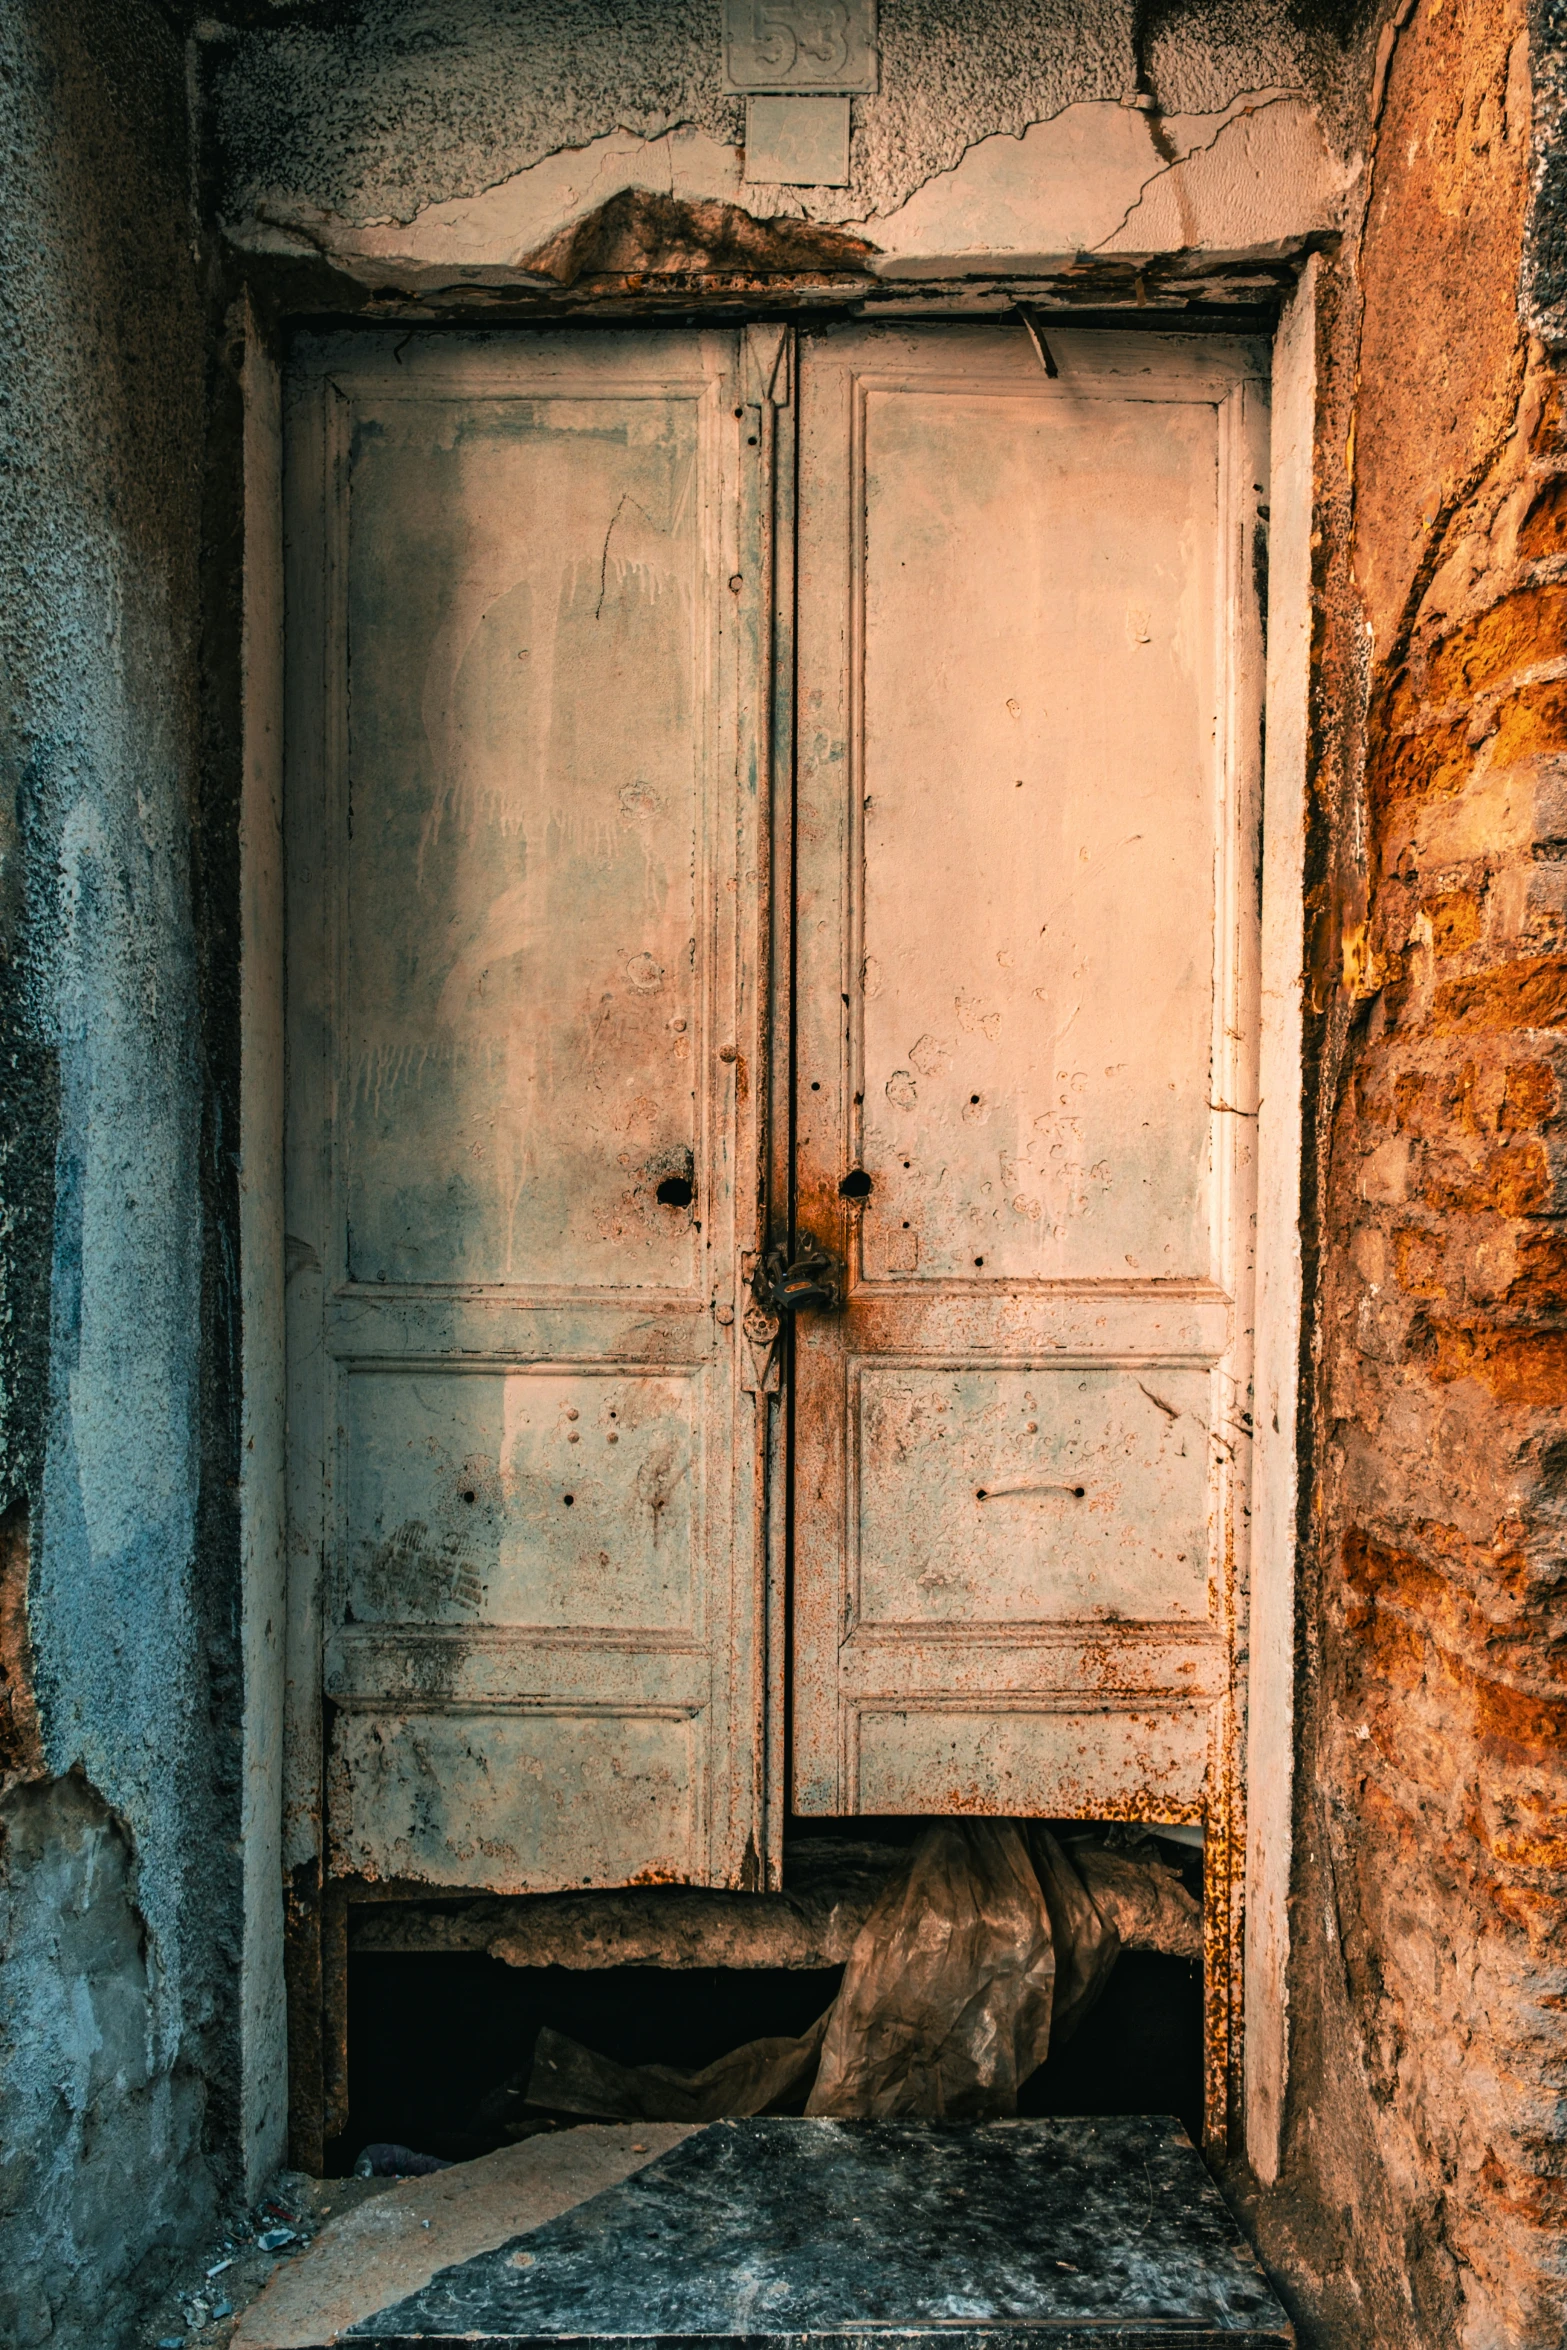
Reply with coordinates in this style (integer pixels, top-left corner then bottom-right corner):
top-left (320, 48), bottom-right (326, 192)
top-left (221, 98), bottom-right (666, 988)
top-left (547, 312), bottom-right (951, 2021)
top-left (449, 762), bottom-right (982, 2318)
top-left (1257, 0), bottom-right (1567, 2350)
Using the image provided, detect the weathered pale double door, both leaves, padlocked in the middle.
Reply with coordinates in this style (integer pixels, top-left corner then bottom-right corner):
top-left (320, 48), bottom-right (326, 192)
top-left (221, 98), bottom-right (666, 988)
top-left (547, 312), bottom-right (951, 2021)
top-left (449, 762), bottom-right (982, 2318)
top-left (287, 320), bottom-right (1266, 1926)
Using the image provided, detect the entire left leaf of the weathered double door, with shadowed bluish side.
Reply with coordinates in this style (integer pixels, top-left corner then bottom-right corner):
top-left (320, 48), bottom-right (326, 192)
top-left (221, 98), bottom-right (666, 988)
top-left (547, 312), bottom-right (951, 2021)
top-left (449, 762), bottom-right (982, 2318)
top-left (287, 331), bottom-right (766, 1926)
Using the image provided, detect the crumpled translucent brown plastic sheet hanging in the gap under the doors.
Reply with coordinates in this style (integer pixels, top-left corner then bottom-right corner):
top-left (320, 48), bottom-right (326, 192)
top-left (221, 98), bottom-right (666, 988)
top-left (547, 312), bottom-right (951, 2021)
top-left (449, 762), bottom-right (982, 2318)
top-left (529, 1819), bottom-right (1165, 2122)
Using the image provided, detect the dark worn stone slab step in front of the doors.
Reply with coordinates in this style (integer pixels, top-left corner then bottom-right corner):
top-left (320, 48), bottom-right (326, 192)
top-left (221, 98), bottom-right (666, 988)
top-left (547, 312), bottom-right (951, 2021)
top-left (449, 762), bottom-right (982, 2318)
top-left (322, 2115), bottom-right (1294, 2350)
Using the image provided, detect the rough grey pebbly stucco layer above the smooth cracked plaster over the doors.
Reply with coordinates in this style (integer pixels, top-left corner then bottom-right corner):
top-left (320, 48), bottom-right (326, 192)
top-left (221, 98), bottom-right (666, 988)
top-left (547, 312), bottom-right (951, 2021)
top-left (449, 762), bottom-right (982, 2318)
top-left (209, 0), bottom-right (1339, 223)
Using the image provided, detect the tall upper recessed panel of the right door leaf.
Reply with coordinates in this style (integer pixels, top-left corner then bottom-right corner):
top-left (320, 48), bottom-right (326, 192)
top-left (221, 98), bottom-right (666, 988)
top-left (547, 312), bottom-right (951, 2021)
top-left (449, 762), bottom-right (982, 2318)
top-left (850, 378), bottom-right (1219, 1283)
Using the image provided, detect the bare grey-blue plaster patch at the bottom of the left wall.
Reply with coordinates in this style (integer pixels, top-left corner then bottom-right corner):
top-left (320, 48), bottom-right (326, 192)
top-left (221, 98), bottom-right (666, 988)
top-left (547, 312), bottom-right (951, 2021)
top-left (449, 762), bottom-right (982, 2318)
top-left (0, 1772), bottom-right (207, 2350)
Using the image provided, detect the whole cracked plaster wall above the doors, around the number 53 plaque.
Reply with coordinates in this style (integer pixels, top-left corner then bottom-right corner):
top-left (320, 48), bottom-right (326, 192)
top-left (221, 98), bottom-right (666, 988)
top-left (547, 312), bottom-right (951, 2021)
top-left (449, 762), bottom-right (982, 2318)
top-left (204, 0), bottom-right (1356, 287)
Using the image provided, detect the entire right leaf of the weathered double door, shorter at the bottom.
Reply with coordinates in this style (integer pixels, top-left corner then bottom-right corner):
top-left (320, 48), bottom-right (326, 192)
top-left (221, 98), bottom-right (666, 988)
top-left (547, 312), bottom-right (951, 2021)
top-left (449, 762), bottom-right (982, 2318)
top-left (794, 324), bottom-right (1266, 1828)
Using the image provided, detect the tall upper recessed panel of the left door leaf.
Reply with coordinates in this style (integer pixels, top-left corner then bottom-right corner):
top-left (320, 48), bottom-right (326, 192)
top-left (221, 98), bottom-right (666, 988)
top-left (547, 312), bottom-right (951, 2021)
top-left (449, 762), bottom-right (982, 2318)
top-left (341, 394), bottom-right (714, 1290)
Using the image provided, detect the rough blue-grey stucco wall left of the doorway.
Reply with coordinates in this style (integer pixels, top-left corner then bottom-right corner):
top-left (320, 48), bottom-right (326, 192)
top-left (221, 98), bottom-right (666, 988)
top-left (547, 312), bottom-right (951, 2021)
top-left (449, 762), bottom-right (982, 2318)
top-left (0, 0), bottom-right (233, 2345)
